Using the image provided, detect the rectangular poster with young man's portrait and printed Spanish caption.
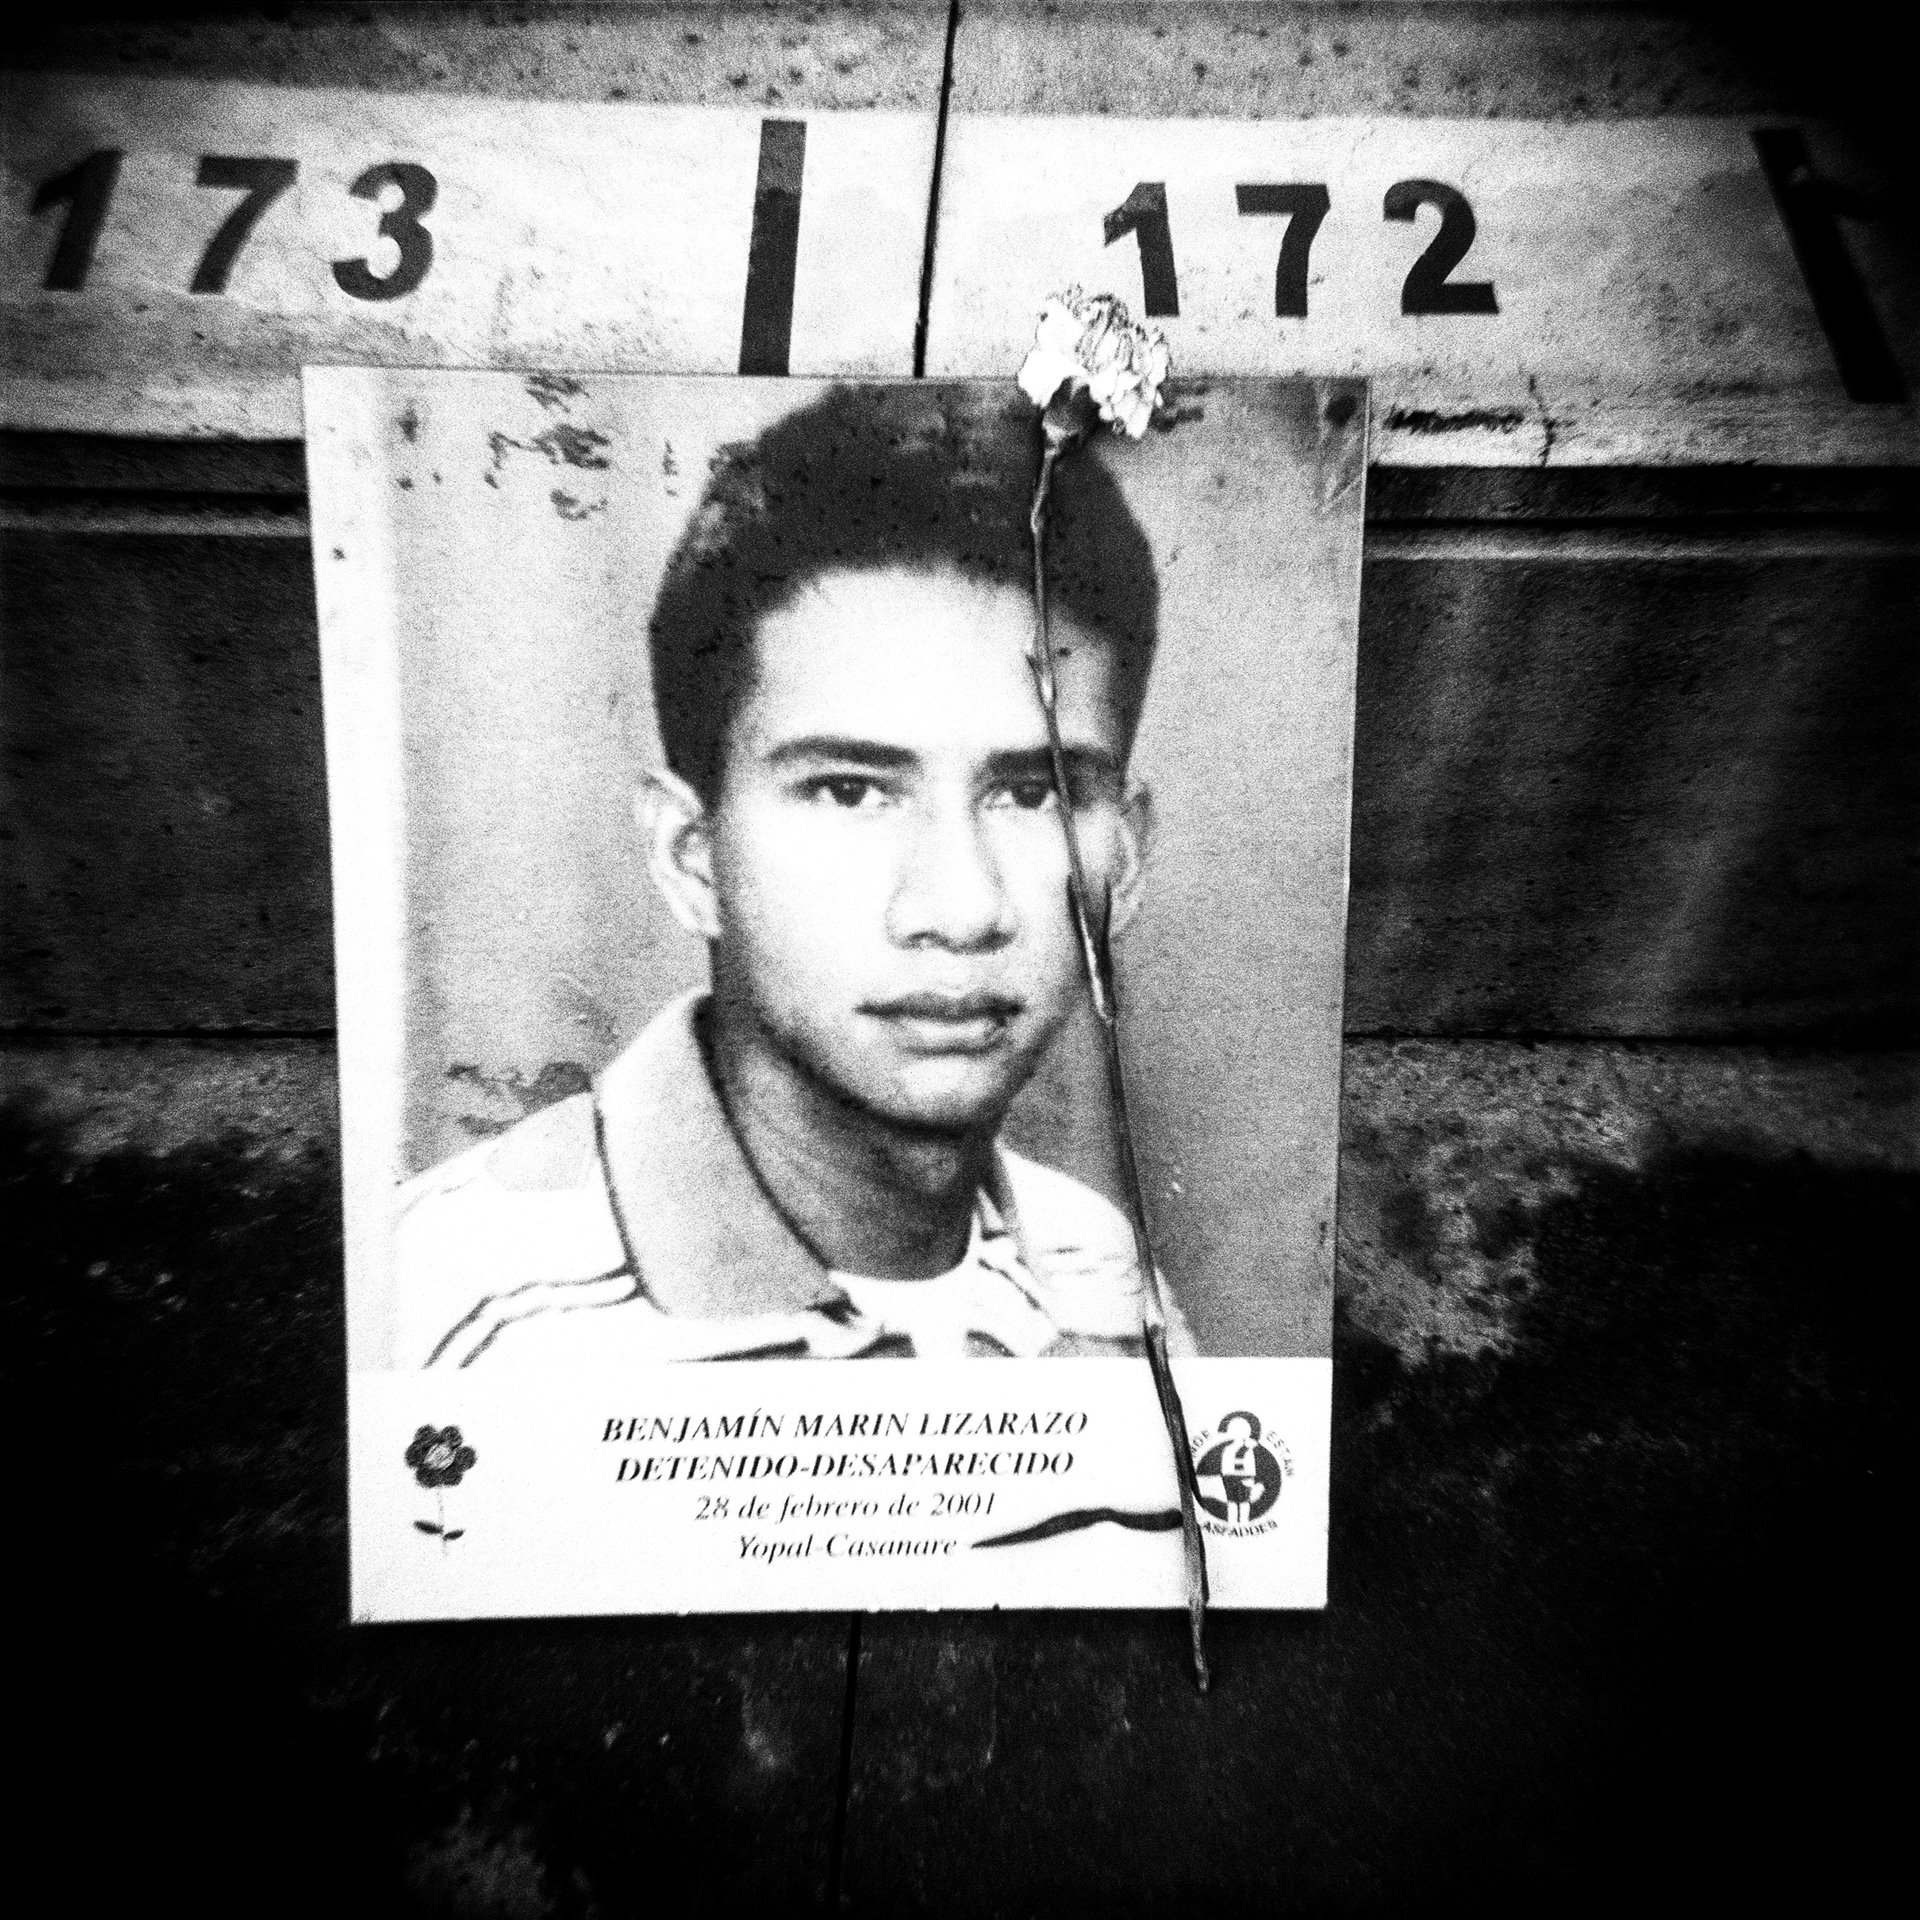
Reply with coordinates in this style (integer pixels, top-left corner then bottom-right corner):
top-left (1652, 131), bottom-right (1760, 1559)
top-left (305, 369), bottom-right (1367, 1620)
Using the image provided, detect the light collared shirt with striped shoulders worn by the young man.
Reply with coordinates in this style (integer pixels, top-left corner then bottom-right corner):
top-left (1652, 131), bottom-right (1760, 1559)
top-left (394, 995), bottom-right (1192, 1369)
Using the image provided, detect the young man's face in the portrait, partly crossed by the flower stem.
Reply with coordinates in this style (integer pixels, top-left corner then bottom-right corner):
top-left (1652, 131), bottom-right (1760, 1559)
top-left (683, 568), bottom-right (1146, 1131)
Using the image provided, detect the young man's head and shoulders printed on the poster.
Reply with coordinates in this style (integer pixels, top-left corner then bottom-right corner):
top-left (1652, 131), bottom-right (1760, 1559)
top-left (396, 388), bottom-right (1182, 1365)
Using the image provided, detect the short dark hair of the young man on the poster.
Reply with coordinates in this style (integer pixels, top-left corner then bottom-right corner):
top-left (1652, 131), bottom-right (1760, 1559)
top-left (649, 382), bottom-right (1160, 804)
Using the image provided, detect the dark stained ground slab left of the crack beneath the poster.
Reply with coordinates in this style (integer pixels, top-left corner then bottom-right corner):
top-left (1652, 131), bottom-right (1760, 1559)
top-left (0, 1043), bottom-right (847, 1916)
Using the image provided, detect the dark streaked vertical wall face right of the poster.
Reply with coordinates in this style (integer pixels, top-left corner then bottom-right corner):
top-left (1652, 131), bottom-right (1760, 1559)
top-left (1346, 536), bottom-right (1920, 1044)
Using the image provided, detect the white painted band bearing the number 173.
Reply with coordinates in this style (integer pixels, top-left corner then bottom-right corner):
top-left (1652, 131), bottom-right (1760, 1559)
top-left (0, 75), bottom-right (933, 438)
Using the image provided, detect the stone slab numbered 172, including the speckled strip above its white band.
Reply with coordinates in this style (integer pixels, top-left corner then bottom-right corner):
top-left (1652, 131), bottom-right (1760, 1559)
top-left (925, 0), bottom-right (1920, 467)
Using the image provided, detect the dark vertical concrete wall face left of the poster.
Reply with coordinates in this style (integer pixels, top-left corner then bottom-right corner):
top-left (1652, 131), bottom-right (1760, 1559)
top-left (0, 534), bottom-right (332, 1027)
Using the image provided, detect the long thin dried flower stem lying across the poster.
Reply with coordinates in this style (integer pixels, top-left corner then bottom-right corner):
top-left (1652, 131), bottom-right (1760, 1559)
top-left (1027, 432), bottom-right (1208, 1693)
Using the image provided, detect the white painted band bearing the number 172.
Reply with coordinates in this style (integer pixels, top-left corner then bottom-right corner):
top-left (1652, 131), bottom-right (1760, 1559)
top-left (927, 115), bottom-right (1920, 467)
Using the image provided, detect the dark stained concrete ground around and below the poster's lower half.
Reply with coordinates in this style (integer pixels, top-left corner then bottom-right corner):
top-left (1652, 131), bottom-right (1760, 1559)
top-left (11, 1041), bottom-right (1920, 1916)
